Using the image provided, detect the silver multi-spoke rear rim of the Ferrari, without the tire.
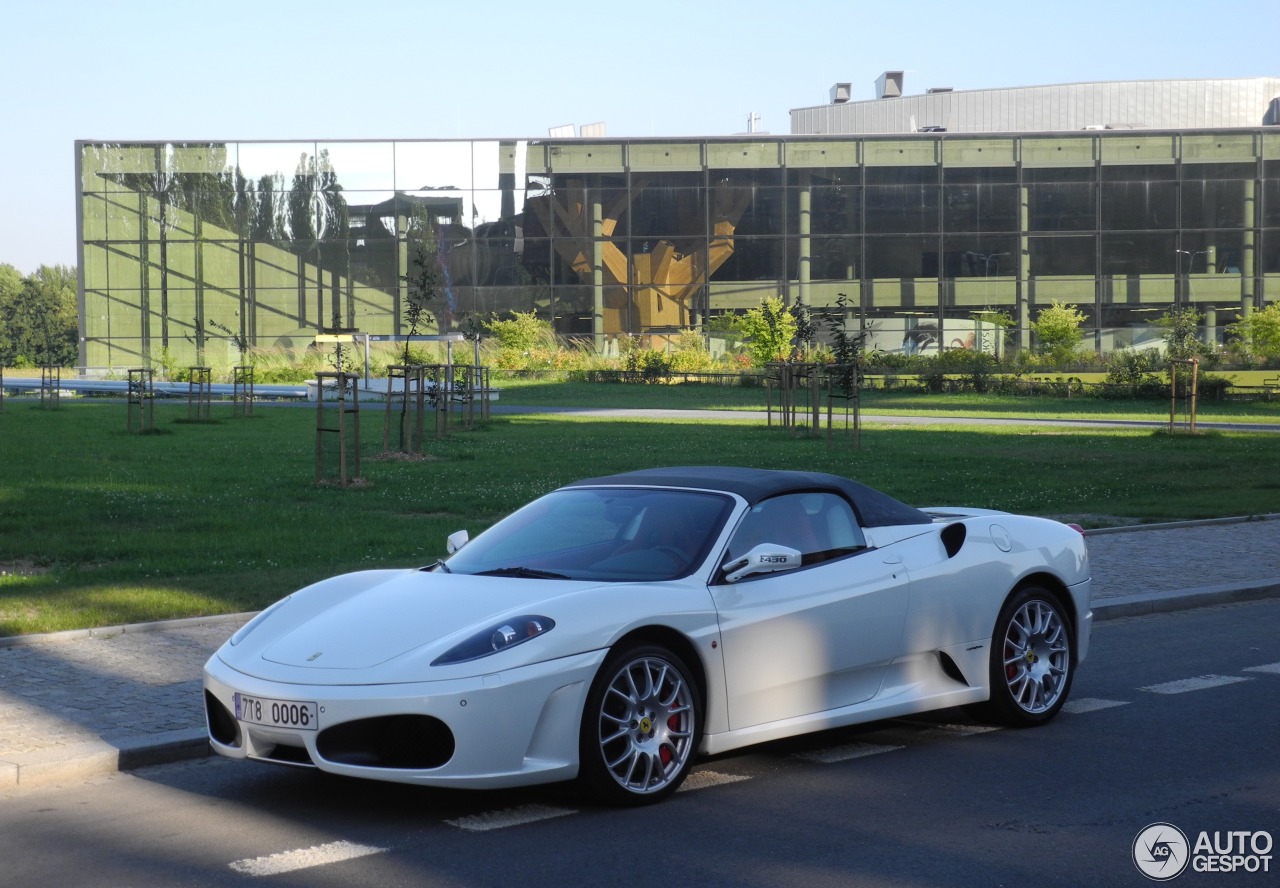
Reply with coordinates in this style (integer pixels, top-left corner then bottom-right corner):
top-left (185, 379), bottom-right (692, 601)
top-left (1004, 599), bottom-right (1071, 714)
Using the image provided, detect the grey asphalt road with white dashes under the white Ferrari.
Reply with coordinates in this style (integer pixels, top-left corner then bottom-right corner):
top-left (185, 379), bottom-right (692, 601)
top-left (0, 600), bottom-right (1280, 888)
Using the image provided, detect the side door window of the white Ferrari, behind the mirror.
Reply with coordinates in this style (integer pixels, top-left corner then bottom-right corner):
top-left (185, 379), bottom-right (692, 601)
top-left (728, 493), bottom-right (867, 564)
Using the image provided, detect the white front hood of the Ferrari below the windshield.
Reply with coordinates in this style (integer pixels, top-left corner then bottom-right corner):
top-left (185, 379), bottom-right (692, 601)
top-left (220, 571), bottom-right (609, 679)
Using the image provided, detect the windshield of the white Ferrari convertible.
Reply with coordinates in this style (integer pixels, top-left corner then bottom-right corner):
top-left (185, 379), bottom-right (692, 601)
top-left (447, 488), bottom-right (733, 582)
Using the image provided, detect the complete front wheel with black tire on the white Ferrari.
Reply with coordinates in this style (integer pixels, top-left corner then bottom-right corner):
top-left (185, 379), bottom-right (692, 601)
top-left (579, 645), bottom-right (703, 805)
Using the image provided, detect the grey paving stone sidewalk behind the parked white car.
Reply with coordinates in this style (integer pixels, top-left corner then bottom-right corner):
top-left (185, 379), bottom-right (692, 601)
top-left (0, 516), bottom-right (1280, 792)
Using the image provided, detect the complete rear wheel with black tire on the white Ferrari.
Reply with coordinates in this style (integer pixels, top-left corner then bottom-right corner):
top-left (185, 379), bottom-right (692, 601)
top-left (979, 586), bottom-right (1075, 728)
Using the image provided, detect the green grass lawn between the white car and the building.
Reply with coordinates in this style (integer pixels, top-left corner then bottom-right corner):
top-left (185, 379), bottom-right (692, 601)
top-left (0, 399), bottom-right (1280, 635)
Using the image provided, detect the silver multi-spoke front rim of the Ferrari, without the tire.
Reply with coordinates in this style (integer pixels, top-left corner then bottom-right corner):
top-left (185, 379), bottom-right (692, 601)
top-left (598, 656), bottom-right (696, 795)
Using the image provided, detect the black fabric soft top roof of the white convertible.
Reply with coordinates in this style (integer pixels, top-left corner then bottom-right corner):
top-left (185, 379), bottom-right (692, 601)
top-left (564, 466), bottom-right (933, 527)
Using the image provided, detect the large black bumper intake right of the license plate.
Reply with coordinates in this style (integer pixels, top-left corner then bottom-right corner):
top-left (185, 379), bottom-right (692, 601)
top-left (316, 715), bottom-right (454, 770)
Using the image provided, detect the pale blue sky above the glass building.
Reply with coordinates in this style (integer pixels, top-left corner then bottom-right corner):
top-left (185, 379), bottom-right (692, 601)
top-left (0, 0), bottom-right (1280, 274)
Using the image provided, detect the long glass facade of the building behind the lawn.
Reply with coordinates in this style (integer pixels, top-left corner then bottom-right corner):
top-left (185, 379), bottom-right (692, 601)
top-left (77, 127), bottom-right (1280, 371)
